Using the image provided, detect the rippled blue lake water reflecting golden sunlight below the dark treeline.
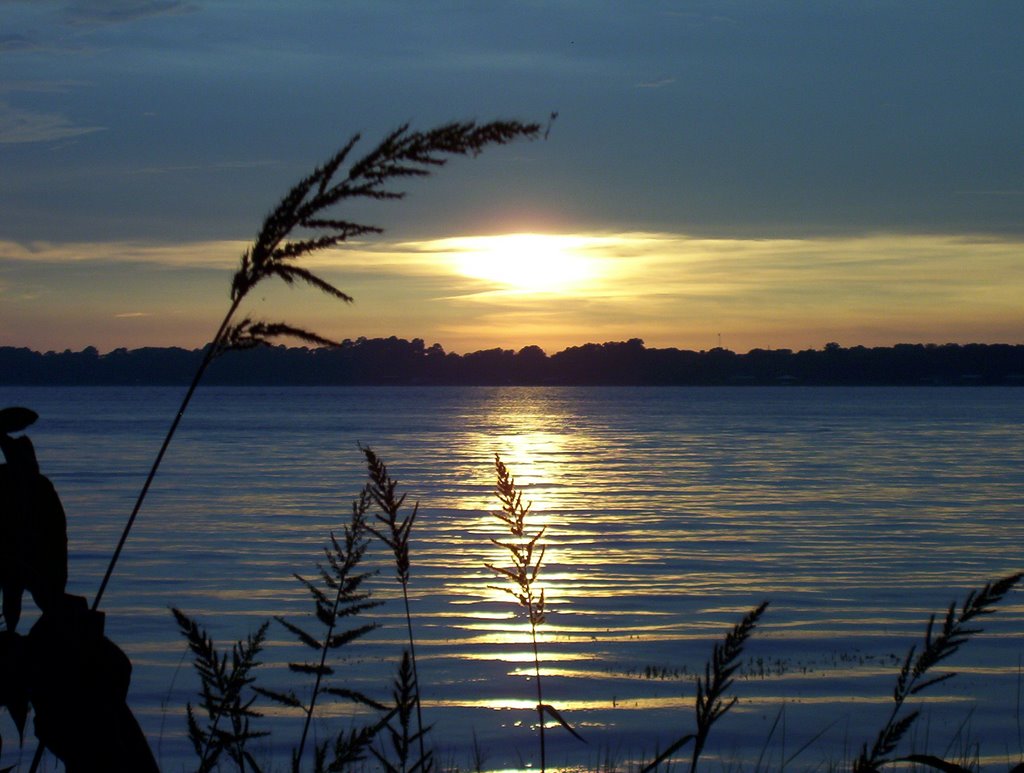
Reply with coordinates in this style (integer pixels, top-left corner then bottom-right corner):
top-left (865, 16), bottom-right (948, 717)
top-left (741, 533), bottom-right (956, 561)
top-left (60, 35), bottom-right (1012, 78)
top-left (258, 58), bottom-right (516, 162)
top-left (0, 387), bottom-right (1024, 771)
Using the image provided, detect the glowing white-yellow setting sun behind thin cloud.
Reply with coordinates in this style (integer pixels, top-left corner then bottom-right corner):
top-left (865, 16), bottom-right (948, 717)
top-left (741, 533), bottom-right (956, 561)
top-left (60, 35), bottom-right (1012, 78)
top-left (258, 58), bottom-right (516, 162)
top-left (447, 233), bottom-right (598, 294)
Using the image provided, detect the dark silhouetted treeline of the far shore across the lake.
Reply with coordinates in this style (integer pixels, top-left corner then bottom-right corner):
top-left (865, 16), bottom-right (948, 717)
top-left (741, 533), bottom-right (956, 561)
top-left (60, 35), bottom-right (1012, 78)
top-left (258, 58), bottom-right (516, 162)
top-left (0, 337), bottom-right (1024, 386)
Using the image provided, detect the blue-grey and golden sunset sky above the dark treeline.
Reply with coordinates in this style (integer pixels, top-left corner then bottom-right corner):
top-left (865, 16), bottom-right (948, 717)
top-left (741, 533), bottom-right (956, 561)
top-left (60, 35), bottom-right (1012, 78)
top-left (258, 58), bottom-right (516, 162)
top-left (0, 0), bottom-right (1024, 352)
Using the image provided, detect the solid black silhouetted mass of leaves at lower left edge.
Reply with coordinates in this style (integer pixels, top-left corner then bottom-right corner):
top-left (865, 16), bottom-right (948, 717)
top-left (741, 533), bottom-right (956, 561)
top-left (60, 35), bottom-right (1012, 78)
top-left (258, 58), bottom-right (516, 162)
top-left (0, 407), bottom-right (159, 773)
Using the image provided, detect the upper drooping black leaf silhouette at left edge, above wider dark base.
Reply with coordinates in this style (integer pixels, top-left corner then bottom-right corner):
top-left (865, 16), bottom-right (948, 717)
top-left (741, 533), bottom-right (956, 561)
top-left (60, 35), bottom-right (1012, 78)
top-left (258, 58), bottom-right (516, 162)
top-left (0, 407), bottom-right (68, 631)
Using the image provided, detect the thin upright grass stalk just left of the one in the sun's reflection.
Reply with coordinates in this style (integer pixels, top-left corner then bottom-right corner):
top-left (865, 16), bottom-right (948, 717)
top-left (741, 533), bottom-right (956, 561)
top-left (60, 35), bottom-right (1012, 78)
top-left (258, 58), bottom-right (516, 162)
top-left (362, 448), bottom-right (427, 761)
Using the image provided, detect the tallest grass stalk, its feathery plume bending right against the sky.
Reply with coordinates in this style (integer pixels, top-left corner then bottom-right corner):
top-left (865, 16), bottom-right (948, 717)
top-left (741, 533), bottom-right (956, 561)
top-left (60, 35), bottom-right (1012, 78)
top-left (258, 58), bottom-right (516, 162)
top-left (92, 121), bottom-right (541, 609)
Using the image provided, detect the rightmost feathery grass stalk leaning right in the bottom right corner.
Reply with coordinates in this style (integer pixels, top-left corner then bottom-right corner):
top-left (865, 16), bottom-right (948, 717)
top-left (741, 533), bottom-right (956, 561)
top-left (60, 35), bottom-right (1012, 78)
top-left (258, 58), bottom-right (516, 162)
top-left (853, 573), bottom-right (1024, 773)
